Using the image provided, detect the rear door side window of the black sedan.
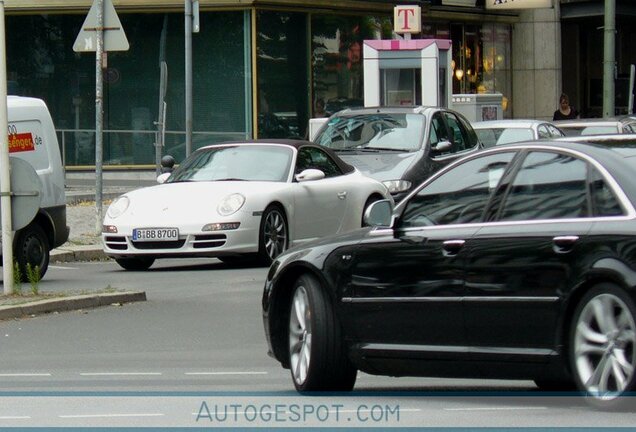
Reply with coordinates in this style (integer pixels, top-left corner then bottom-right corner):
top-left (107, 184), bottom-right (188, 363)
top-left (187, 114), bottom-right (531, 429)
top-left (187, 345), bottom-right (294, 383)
top-left (499, 152), bottom-right (589, 221)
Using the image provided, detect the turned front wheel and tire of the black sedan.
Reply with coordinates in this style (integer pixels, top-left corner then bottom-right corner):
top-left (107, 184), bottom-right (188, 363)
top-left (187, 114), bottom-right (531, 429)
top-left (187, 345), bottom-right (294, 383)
top-left (289, 274), bottom-right (357, 392)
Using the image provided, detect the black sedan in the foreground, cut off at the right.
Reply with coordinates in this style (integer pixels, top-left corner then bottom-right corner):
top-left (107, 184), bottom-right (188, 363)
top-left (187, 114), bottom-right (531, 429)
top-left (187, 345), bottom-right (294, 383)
top-left (262, 142), bottom-right (636, 407)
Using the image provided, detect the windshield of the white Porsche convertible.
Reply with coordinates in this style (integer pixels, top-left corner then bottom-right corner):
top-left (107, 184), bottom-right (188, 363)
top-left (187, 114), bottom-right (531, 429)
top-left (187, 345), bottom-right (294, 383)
top-left (166, 144), bottom-right (293, 183)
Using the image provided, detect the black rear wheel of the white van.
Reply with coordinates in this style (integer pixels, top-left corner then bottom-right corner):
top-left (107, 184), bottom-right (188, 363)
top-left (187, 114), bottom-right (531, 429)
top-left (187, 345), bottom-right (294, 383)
top-left (15, 225), bottom-right (49, 282)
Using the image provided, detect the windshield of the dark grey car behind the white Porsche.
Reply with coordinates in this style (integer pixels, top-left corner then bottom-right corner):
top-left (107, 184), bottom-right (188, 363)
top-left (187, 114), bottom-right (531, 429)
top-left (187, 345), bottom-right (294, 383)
top-left (315, 113), bottom-right (426, 151)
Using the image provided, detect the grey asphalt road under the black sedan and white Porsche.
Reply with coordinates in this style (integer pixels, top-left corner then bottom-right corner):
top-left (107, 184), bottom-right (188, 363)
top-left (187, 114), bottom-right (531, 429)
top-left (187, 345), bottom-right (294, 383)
top-left (0, 259), bottom-right (634, 427)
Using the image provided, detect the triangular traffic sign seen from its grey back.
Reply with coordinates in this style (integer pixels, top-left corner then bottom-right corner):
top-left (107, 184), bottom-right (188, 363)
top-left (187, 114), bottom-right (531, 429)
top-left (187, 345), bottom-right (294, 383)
top-left (73, 0), bottom-right (129, 52)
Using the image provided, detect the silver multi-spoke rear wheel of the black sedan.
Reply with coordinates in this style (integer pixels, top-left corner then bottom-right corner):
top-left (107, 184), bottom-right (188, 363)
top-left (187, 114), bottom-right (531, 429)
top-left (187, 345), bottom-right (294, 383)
top-left (570, 283), bottom-right (636, 408)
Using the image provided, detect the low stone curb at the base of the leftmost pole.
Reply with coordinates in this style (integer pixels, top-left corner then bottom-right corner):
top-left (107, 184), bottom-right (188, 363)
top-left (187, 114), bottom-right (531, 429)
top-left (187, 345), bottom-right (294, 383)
top-left (0, 291), bottom-right (146, 320)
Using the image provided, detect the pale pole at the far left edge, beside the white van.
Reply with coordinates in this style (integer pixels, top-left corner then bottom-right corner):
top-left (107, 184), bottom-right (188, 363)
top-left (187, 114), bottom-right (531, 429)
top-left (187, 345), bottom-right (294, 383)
top-left (0, 0), bottom-right (13, 295)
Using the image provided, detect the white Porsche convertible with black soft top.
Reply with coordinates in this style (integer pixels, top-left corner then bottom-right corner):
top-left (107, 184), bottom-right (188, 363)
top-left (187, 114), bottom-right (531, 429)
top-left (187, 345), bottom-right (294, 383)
top-left (102, 140), bottom-right (391, 270)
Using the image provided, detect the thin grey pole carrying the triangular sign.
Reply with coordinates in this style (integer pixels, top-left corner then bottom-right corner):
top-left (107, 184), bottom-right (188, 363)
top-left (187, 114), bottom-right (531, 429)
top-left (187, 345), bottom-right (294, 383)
top-left (95, 0), bottom-right (104, 235)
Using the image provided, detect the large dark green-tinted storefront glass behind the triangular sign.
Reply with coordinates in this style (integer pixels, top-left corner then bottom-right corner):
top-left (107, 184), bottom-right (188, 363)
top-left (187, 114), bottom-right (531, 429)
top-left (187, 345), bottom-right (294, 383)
top-left (6, 12), bottom-right (249, 166)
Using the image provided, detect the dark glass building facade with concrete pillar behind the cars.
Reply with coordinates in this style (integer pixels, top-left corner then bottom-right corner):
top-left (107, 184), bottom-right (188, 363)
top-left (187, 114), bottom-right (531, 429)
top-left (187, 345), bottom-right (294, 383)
top-left (5, 0), bottom-right (536, 170)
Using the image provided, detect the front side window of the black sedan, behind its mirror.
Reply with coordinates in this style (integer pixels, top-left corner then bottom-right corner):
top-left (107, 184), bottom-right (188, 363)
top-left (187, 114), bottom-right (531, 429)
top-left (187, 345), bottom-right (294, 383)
top-left (401, 152), bottom-right (515, 228)
